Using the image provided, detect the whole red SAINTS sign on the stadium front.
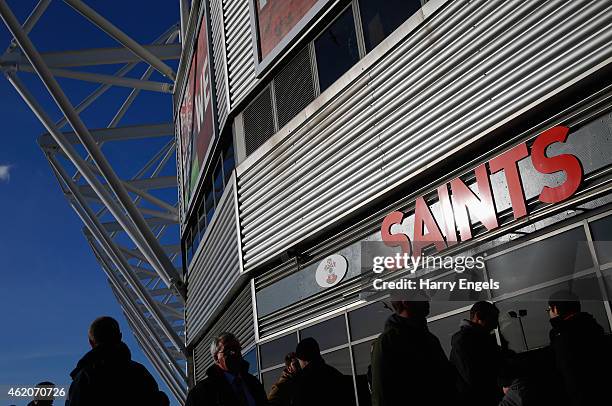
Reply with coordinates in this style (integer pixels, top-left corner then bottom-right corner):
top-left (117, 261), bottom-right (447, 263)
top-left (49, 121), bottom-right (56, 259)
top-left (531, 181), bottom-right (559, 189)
top-left (381, 126), bottom-right (583, 257)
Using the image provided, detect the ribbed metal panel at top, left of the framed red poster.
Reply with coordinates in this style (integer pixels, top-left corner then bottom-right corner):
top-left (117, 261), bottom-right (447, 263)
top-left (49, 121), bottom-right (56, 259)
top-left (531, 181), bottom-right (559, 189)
top-left (222, 0), bottom-right (257, 106)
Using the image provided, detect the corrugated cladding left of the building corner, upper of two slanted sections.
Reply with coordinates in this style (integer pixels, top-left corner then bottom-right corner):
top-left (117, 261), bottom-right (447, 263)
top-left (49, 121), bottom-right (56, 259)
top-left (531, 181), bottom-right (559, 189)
top-left (185, 174), bottom-right (240, 345)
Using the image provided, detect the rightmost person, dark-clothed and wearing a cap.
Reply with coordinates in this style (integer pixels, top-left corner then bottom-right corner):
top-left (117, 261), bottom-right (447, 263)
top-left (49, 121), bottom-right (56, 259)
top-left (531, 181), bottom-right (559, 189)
top-left (547, 291), bottom-right (612, 406)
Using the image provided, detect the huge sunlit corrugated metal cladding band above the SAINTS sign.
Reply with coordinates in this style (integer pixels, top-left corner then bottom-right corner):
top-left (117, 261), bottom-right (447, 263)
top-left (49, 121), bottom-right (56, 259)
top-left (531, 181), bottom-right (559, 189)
top-left (238, 0), bottom-right (612, 270)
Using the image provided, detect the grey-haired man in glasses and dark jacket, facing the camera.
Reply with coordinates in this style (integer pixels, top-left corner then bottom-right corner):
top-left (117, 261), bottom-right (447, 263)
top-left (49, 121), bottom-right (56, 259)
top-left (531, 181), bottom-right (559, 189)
top-left (185, 332), bottom-right (268, 406)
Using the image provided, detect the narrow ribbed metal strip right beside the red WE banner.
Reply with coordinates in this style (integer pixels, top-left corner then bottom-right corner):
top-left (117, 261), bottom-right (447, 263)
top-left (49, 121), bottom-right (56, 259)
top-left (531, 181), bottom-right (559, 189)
top-left (210, 0), bottom-right (229, 128)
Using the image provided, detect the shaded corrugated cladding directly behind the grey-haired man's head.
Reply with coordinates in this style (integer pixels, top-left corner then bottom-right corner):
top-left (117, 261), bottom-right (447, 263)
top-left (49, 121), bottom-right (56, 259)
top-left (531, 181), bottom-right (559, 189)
top-left (193, 285), bottom-right (255, 382)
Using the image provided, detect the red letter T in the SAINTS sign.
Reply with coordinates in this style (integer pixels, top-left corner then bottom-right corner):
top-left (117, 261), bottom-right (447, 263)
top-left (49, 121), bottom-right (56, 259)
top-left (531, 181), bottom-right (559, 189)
top-left (489, 143), bottom-right (529, 219)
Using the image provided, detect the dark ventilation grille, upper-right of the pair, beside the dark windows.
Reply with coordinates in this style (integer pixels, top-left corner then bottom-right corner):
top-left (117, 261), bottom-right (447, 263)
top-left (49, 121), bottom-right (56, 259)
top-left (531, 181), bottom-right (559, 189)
top-left (274, 47), bottom-right (315, 128)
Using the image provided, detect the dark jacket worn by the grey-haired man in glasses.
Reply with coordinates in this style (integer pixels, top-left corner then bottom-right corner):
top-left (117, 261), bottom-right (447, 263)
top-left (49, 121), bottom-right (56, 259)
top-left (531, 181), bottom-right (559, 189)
top-left (185, 361), bottom-right (268, 406)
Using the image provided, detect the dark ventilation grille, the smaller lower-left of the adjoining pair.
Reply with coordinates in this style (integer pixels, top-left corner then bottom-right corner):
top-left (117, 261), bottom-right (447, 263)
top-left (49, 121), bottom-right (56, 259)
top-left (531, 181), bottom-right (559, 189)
top-left (242, 86), bottom-right (275, 155)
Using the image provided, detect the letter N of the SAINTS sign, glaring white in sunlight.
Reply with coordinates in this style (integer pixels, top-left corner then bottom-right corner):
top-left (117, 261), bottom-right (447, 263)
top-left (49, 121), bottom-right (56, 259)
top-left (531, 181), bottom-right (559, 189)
top-left (450, 164), bottom-right (498, 241)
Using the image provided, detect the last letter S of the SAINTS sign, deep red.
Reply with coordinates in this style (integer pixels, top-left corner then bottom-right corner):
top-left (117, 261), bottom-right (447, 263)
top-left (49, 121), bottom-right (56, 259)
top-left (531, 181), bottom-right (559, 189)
top-left (531, 126), bottom-right (583, 203)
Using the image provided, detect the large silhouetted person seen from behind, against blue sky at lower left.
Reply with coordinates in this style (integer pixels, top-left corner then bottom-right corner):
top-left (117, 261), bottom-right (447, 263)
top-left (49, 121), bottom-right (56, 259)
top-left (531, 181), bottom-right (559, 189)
top-left (66, 316), bottom-right (160, 406)
